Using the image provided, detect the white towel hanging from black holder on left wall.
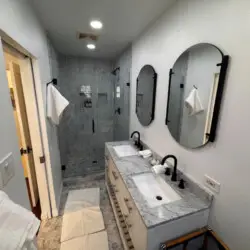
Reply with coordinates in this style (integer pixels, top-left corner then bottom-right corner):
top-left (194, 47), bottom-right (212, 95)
top-left (47, 84), bottom-right (69, 125)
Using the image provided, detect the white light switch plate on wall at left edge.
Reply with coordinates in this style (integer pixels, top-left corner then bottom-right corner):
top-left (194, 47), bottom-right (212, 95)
top-left (0, 153), bottom-right (15, 186)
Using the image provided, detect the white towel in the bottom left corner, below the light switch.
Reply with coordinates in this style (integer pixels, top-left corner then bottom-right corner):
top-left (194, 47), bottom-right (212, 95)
top-left (0, 191), bottom-right (40, 250)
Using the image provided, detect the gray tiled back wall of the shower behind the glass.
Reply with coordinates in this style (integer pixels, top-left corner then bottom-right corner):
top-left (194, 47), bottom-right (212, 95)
top-left (58, 56), bottom-right (114, 177)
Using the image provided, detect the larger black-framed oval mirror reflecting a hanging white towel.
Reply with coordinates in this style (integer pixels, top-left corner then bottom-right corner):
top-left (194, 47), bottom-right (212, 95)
top-left (166, 43), bottom-right (229, 148)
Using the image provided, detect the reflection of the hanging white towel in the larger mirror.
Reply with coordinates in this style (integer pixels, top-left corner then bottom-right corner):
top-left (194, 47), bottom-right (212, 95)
top-left (185, 89), bottom-right (204, 116)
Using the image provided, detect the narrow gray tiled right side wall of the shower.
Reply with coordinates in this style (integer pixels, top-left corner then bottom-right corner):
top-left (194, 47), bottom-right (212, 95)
top-left (114, 47), bottom-right (132, 141)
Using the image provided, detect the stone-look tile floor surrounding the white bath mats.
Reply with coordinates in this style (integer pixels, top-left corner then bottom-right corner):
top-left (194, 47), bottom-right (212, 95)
top-left (38, 173), bottom-right (123, 250)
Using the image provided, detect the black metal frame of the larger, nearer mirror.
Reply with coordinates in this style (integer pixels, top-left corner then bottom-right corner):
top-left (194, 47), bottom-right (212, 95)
top-left (165, 43), bottom-right (229, 144)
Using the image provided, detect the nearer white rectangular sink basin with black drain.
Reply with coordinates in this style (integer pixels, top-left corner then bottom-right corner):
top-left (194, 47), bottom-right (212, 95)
top-left (132, 173), bottom-right (181, 207)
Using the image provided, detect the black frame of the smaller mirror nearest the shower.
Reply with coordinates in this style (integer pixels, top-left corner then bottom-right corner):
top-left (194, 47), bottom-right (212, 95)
top-left (135, 64), bottom-right (158, 127)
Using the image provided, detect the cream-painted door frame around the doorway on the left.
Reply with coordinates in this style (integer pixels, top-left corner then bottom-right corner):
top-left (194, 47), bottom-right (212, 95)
top-left (0, 30), bottom-right (52, 220)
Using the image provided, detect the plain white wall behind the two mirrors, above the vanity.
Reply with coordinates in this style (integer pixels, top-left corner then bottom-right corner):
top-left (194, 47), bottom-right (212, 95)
top-left (130, 0), bottom-right (250, 250)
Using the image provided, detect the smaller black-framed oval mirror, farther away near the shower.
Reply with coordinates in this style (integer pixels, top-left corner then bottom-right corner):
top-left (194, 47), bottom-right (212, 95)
top-left (136, 65), bottom-right (157, 126)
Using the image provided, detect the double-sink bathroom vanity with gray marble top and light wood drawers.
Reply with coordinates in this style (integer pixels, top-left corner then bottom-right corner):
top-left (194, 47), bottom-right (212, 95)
top-left (105, 141), bottom-right (212, 250)
